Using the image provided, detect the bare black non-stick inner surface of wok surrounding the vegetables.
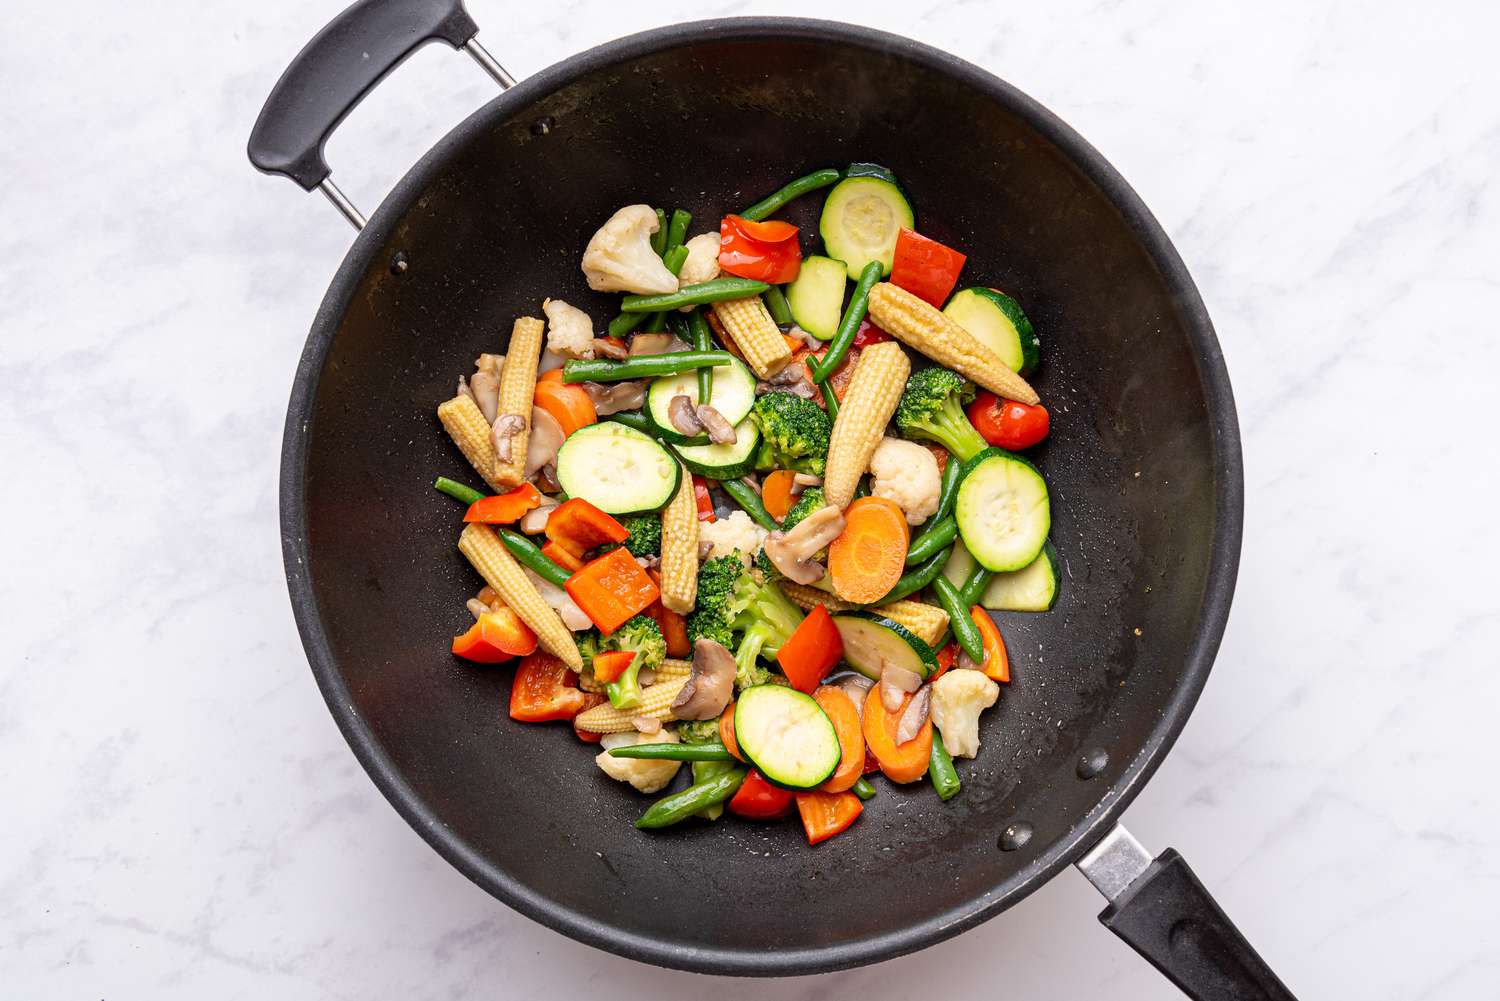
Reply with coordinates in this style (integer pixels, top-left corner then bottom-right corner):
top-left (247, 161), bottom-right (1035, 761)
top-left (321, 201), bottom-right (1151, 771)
top-left (294, 29), bottom-right (1217, 969)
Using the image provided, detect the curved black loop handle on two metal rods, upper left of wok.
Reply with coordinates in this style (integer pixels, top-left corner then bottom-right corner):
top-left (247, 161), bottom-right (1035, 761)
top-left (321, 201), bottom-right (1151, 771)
top-left (246, 0), bottom-right (516, 230)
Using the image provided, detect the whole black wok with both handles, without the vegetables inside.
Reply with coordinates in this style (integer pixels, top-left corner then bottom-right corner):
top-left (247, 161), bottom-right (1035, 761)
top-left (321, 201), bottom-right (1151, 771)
top-left (251, 0), bottom-right (1290, 998)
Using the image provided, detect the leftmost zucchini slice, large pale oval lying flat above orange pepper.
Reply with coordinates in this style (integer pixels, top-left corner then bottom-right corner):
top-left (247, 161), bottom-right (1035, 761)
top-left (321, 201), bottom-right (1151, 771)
top-left (558, 420), bottom-right (683, 515)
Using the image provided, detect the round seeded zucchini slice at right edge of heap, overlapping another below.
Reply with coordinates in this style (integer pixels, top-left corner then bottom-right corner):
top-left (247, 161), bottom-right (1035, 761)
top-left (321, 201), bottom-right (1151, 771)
top-left (953, 449), bottom-right (1052, 573)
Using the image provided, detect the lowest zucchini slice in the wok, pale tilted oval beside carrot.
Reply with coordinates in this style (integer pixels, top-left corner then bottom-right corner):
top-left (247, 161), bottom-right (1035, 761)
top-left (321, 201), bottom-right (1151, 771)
top-left (735, 684), bottom-right (843, 789)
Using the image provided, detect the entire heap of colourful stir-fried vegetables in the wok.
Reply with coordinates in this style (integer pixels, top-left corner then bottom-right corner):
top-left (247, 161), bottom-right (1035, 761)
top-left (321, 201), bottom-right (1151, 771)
top-left (435, 164), bottom-right (1059, 845)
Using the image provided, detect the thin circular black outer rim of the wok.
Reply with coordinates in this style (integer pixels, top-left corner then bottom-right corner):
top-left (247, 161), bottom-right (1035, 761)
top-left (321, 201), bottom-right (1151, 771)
top-left (281, 17), bottom-right (1244, 975)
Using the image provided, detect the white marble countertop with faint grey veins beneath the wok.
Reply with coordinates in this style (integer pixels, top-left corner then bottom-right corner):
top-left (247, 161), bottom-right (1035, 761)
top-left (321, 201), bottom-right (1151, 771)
top-left (0, 0), bottom-right (1500, 1001)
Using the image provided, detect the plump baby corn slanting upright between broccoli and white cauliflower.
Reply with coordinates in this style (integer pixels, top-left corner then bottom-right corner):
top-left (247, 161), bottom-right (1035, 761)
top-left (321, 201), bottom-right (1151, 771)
top-left (824, 342), bottom-right (906, 510)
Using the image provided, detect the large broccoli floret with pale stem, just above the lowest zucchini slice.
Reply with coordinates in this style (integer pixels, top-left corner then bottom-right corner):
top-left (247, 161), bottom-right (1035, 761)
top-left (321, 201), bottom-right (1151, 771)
top-left (687, 557), bottom-right (803, 689)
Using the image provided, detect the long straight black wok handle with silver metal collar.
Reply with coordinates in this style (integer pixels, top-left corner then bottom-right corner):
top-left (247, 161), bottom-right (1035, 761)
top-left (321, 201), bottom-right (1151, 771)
top-left (1079, 825), bottom-right (1296, 1001)
